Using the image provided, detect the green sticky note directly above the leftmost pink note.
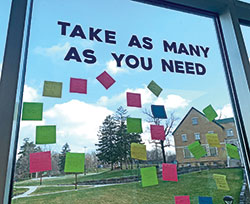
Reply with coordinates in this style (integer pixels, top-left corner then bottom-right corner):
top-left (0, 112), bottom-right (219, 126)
top-left (36, 125), bottom-right (56, 144)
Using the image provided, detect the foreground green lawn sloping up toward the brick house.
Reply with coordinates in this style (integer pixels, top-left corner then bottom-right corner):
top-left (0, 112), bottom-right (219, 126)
top-left (12, 169), bottom-right (243, 204)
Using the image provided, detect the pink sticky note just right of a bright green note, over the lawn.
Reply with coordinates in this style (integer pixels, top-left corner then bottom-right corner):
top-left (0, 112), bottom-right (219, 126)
top-left (162, 163), bottom-right (178, 182)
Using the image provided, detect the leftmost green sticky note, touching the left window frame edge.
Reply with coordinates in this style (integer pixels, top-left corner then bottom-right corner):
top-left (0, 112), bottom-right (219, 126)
top-left (22, 102), bottom-right (43, 120)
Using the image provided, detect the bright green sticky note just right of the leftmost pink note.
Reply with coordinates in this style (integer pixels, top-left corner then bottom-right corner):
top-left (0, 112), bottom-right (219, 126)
top-left (64, 152), bottom-right (85, 173)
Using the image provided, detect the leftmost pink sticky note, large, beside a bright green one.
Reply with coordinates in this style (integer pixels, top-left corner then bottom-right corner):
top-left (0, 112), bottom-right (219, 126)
top-left (30, 151), bottom-right (51, 173)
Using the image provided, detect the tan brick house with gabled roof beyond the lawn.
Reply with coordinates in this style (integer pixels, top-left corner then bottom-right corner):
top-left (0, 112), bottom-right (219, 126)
top-left (173, 107), bottom-right (241, 167)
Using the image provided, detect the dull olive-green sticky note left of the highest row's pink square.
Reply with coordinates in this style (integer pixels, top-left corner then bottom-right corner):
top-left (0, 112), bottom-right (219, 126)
top-left (43, 81), bottom-right (62, 98)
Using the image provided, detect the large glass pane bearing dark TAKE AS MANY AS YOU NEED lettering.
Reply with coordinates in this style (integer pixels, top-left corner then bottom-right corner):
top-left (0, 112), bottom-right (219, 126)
top-left (10, 0), bottom-right (249, 204)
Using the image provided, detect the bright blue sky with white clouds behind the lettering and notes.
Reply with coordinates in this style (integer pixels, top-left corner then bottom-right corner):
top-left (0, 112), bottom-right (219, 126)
top-left (0, 0), bottom-right (238, 152)
